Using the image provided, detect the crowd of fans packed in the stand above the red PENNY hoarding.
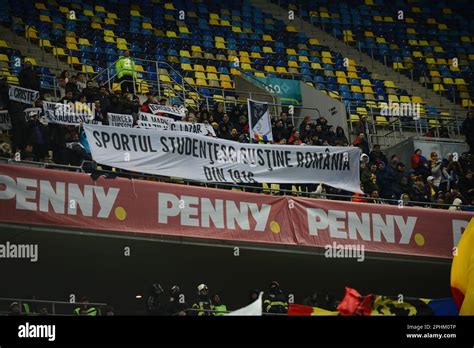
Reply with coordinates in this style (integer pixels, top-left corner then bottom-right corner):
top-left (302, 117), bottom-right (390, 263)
top-left (0, 63), bottom-right (474, 209)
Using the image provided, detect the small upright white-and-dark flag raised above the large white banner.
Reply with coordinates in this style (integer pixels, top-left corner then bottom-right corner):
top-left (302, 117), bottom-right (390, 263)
top-left (247, 99), bottom-right (273, 141)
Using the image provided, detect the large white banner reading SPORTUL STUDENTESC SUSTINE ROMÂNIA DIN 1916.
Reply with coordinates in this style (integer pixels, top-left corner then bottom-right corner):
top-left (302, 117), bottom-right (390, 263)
top-left (84, 125), bottom-right (360, 192)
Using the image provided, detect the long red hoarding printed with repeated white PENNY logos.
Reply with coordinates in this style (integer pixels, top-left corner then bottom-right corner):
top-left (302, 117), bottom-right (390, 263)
top-left (0, 164), bottom-right (474, 258)
